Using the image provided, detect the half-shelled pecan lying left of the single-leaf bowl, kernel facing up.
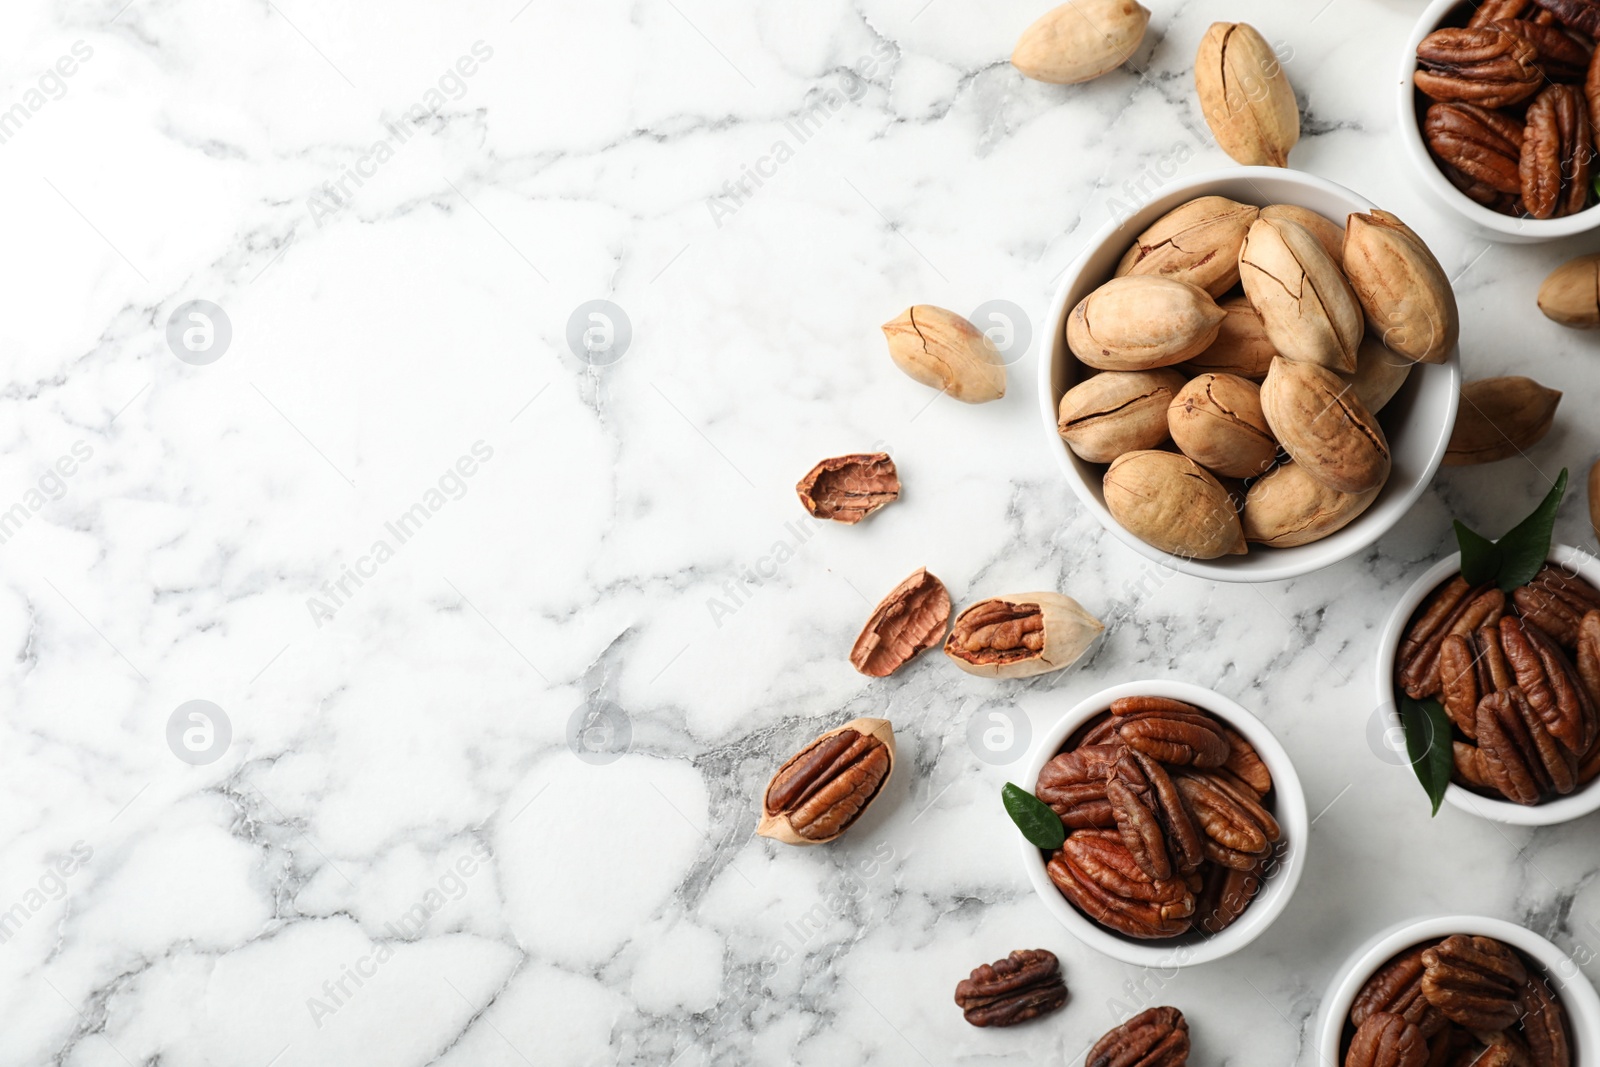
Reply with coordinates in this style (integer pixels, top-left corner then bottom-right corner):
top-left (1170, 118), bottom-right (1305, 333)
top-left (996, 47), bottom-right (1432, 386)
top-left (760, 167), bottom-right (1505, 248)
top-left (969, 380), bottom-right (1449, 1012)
top-left (755, 718), bottom-right (894, 845)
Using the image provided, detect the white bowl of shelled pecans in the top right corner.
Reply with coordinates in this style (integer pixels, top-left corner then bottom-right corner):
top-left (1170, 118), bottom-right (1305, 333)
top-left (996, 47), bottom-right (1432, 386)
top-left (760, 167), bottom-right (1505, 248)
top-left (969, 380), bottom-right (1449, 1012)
top-left (1398, 0), bottom-right (1600, 242)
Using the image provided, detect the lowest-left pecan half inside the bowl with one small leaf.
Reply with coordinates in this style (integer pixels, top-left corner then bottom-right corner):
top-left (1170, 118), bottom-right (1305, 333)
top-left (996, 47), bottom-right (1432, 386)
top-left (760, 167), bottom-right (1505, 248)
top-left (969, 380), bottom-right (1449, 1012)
top-left (1048, 830), bottom-right (1195, 939)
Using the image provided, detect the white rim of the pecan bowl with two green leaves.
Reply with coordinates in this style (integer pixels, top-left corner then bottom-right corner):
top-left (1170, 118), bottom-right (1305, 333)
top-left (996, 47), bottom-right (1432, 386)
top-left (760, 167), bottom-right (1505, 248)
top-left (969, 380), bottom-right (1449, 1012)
top-left (1378, 544), bottom-right (1600, 825)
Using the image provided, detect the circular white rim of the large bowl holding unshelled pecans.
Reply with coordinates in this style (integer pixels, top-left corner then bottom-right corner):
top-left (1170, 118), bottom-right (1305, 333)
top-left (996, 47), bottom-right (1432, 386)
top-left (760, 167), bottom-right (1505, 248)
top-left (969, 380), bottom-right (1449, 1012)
top-left (1038, 166), bottom-right (1461, 584)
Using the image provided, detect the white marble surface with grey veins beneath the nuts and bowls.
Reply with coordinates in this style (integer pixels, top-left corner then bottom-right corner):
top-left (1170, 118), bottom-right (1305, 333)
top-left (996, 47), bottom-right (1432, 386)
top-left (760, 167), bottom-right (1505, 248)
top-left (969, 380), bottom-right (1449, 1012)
top-left (9, 0), bottom-right (1600, 1067)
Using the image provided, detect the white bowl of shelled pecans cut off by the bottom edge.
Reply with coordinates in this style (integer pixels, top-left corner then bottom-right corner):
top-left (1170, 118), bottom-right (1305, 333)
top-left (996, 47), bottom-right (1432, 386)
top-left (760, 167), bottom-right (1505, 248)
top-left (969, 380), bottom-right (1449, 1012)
top-left (1317, 915), bottom-right (1600, 1067)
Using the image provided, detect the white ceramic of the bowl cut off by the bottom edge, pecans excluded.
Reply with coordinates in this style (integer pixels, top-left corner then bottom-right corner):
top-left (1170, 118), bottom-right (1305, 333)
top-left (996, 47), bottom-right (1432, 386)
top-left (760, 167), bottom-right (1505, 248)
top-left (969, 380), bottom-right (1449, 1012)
top-left (1317, 915), bottom-right (1600, 1067)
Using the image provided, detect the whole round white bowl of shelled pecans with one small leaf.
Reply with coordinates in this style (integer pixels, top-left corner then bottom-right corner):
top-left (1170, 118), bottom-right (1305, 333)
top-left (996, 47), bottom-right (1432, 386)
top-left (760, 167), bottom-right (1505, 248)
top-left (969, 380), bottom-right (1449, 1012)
top-left (1022, 681), bottom-right (1307, 966)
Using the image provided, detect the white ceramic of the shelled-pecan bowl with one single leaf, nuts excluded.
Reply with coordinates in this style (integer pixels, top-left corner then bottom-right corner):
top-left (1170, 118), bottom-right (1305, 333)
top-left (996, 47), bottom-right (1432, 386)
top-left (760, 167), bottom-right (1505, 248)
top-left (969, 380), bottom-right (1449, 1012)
top-left (1018, 681), bottom-right (1310, 968)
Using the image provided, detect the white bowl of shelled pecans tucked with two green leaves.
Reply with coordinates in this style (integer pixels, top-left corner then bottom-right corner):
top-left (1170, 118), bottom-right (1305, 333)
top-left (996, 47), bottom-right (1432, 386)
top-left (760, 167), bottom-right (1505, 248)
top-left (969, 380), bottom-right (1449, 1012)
top-left (1378, 544), bottom-right (1600, 825)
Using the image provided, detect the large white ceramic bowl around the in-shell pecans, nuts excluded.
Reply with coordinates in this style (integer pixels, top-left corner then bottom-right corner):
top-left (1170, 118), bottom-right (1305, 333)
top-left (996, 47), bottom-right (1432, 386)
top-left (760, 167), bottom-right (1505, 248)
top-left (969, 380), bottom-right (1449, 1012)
top-left (1038, 166), bottom-right (1461, 582)
